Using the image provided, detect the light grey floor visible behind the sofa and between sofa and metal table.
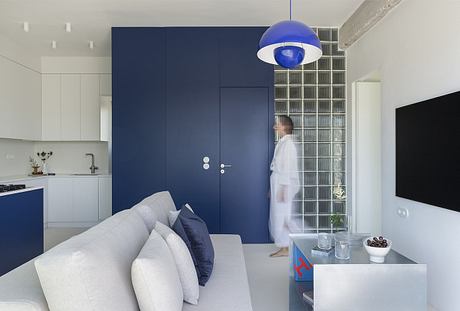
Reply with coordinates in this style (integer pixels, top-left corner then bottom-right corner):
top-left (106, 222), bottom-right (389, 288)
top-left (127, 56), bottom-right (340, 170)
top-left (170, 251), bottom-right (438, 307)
top-left (45, 228), bottom-right (289, 311)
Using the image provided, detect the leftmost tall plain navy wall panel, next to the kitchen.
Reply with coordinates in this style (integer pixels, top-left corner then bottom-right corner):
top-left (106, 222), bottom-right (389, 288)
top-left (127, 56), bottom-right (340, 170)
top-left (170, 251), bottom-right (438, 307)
top-left (112, 28), bottom-right (166, 213)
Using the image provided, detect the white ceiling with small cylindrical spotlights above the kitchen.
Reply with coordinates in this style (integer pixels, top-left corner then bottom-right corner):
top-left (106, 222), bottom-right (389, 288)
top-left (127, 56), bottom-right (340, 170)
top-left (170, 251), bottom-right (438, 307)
top-left (0, 0), bottom-right (364, 56)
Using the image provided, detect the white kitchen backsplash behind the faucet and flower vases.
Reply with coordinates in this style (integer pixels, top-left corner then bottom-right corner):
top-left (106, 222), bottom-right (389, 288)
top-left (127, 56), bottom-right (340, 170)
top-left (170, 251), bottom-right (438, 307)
top-left (0, 138), bottom-right (109, 177)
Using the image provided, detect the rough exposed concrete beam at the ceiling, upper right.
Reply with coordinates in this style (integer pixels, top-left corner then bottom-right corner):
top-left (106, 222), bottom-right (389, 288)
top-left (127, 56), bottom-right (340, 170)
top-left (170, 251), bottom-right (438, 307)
top-left (339, 0), bottom-right (402, 50)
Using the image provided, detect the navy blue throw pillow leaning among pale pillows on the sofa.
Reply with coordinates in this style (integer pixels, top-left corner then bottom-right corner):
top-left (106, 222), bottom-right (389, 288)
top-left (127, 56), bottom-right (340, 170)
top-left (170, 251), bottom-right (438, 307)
top-left (173, 208), bottom-right (214, 286)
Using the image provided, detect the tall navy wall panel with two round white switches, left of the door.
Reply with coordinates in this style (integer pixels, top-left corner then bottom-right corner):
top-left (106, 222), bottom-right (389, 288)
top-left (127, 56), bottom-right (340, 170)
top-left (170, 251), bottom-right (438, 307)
top-left (166, 28), bottom-right (219, 232)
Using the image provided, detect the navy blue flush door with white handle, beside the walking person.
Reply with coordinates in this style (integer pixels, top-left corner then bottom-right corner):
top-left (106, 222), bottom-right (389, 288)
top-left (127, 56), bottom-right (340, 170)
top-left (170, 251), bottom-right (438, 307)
top-left (219, 87), bottom-right (270, 243)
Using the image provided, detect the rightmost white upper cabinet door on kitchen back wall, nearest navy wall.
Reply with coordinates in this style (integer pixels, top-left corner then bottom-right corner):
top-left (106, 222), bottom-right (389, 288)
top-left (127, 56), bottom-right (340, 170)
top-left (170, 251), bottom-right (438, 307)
top-left (81, 74), bottom-right (101, 140)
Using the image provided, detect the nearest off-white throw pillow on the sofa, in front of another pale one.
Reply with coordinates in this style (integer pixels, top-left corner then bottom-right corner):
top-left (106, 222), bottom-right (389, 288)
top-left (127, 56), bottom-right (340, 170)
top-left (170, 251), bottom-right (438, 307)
top-left (131, 230), bottom-right (183, 311)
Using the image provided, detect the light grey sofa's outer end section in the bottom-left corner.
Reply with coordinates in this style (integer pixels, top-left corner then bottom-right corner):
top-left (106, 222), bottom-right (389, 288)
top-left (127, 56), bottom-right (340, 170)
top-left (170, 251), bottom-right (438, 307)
top-left (0, 258), bottom-right (49, 311)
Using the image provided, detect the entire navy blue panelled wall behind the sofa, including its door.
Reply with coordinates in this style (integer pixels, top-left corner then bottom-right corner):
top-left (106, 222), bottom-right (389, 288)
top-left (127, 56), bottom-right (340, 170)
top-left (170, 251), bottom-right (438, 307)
top-left (112, 27), bottom-right (273, 242)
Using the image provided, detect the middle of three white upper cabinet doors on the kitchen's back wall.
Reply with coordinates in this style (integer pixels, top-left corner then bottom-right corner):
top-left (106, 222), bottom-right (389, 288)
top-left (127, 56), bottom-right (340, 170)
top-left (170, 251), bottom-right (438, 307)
top-left (61, 74), bottom-right (81, 141)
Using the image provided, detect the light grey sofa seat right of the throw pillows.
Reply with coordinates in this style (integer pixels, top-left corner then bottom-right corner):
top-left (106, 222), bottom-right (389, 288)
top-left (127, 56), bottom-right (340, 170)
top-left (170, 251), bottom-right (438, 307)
top-left (182, 234), bottom-right (252, 311)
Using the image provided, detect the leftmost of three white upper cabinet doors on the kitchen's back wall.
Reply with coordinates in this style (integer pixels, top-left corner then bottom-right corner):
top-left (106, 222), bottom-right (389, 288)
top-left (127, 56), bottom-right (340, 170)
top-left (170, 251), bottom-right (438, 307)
top-left (42, 74), bottom-right (61, 141)
